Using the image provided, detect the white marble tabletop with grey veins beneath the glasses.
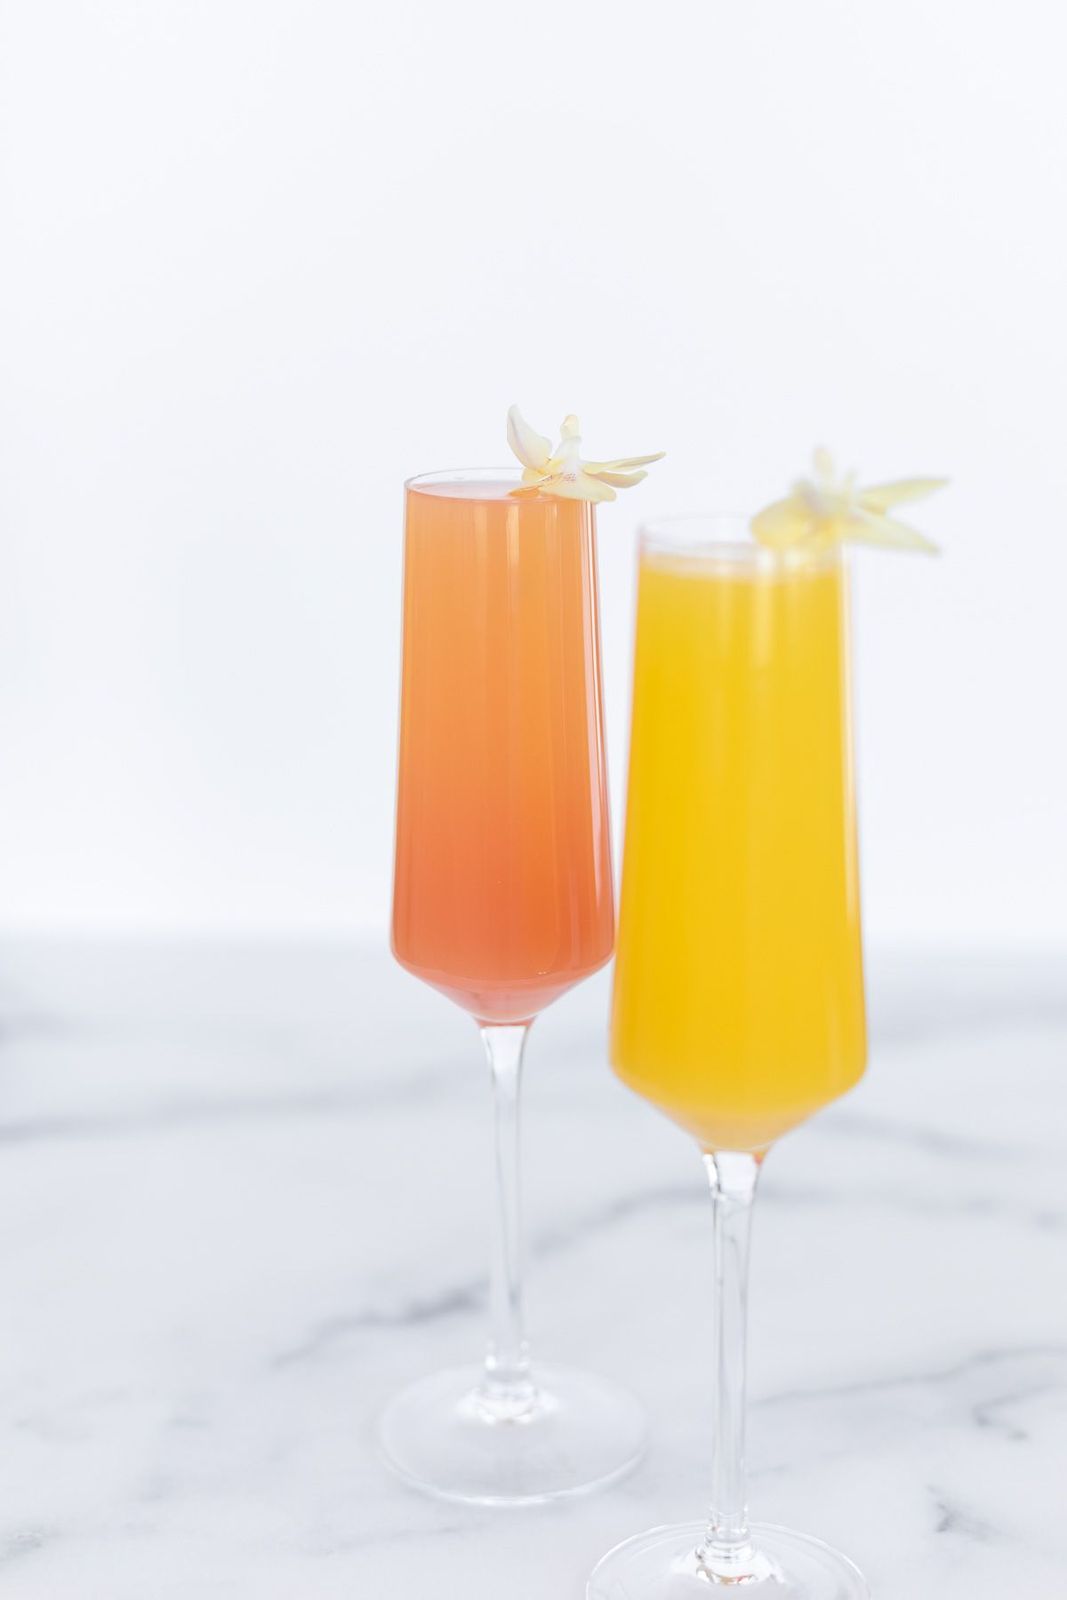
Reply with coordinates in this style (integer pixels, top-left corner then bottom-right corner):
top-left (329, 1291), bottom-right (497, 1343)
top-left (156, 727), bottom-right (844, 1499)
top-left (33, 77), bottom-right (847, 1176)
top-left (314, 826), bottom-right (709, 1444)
top-left (0, 942), bottom-right (1067, 1600)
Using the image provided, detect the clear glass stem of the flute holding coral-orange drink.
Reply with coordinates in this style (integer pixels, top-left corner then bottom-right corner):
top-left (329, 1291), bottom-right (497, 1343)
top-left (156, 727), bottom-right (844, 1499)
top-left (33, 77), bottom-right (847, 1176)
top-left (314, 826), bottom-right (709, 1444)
top-left (482, 1022), bottom-right (533, 1414)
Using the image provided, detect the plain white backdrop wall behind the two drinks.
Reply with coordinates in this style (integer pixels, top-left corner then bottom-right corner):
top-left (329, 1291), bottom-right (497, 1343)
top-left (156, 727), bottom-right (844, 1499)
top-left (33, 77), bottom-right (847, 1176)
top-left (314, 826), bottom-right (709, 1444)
top-left (0, 0), bottom-right (1067, 942)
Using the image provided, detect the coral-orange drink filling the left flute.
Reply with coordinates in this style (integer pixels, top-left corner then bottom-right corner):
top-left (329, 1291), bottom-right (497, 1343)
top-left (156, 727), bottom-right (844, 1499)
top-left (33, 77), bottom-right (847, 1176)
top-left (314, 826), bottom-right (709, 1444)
top-left (392, 482), bottom-right (614, 1022)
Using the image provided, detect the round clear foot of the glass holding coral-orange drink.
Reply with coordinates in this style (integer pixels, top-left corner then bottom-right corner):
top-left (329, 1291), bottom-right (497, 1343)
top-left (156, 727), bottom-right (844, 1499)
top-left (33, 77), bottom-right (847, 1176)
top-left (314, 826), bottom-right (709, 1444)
top-left (381, 1366), bottom-right (645, 1506)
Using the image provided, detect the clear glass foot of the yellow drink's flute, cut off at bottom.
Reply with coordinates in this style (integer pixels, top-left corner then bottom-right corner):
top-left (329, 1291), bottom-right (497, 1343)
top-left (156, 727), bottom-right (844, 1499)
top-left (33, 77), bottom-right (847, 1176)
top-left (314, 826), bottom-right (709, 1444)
top-left (585, 1522), bottom-right (870, 1600)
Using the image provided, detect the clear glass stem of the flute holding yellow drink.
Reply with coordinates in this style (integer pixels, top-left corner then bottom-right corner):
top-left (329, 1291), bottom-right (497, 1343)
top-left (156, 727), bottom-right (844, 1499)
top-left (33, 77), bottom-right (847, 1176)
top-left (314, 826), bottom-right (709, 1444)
top-left (697, 1150), bottom-right (761, 1582)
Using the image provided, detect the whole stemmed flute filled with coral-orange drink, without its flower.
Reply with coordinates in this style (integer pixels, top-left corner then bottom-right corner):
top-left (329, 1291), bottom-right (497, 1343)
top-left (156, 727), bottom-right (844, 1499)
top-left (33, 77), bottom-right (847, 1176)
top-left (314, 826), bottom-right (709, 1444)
top-left (382, 470), bottom-right (645, 1502)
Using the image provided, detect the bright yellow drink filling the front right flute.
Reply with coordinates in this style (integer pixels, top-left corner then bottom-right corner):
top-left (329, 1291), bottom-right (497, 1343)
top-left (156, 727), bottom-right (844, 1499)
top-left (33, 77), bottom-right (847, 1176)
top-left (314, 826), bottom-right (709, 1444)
top-left (613, 554), bottom-right (867, 1150)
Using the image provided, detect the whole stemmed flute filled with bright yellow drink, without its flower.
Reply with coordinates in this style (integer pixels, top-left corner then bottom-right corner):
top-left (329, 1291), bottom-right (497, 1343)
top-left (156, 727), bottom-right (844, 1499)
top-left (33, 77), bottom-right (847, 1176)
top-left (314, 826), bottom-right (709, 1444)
top-left (587, 517), bottom-right (869, 1600)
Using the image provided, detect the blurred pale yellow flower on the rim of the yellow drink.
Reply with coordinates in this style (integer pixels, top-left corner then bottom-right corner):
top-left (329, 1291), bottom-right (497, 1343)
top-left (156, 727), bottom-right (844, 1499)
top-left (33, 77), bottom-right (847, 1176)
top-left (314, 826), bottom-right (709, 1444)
top-left (752, 450), bottom-right (947, 554)
